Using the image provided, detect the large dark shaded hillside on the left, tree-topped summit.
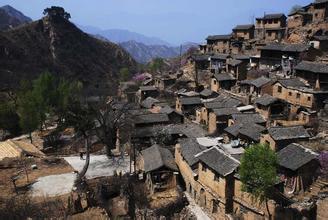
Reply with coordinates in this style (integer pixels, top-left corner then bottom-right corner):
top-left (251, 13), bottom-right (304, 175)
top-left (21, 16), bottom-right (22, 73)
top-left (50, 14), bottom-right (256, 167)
top-left (0, 16), bottom-right (136, 95)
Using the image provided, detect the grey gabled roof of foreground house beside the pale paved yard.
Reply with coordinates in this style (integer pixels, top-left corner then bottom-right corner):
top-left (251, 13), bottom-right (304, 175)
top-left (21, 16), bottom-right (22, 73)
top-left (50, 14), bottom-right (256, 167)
top-left (141, 144), bottom-right (178, 172)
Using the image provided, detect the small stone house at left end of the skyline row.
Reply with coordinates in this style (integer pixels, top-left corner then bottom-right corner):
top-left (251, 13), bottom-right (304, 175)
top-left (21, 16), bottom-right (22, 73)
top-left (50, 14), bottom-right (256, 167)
top-left (206, 34), bottom-right (232, 53)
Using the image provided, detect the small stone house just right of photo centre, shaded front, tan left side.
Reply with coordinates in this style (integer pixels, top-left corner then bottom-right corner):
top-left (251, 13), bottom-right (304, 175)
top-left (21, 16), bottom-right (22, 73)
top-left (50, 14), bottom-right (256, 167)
top-left (175, 97), bottom-right (203, 116)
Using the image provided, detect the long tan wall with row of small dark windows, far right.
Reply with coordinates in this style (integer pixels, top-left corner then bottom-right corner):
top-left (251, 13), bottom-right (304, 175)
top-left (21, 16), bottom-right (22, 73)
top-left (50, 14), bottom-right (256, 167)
top-left (272, 82), bottom-right (314, 108)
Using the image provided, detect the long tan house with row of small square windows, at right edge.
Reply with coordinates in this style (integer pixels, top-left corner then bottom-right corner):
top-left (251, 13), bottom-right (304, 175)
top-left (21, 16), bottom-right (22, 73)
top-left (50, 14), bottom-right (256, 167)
top-left (272, 78), bottom-right (327, 113)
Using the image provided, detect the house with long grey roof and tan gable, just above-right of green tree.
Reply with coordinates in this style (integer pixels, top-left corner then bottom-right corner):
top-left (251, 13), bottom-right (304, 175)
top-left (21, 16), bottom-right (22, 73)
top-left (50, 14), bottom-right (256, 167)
top-left (261, 126), bottom-right (311, 151)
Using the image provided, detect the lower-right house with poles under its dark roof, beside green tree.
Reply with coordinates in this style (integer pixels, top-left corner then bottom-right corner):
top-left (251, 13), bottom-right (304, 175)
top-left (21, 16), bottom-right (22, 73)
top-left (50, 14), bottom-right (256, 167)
top-left (277, 143), bottom-right (320, 195)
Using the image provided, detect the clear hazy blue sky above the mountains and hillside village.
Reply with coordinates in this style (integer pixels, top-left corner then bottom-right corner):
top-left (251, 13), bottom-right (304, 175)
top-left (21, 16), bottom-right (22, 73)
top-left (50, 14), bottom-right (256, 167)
top-left (0, 0), bottom-right (314, 44)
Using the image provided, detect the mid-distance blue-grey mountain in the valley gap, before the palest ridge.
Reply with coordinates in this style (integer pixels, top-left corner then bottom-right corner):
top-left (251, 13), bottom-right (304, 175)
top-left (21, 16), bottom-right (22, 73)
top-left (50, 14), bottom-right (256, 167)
top-left (120, 41), bottom-right (197, 63)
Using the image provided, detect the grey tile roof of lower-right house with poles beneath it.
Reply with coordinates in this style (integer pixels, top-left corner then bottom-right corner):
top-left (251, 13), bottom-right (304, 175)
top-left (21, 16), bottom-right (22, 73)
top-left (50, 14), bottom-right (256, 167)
top-left (277, 143), bottom-right (318, 171)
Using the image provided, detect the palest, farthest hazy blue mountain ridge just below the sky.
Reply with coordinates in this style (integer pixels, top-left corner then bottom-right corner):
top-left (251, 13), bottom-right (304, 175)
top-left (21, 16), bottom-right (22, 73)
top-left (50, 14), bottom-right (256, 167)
top-left (79, 26), bottom-right (172, 46)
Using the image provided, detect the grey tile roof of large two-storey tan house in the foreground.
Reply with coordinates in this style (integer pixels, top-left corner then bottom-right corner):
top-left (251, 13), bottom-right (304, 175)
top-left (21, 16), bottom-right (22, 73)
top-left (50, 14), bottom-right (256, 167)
top-left (197, 147), bottom-right (240, 177)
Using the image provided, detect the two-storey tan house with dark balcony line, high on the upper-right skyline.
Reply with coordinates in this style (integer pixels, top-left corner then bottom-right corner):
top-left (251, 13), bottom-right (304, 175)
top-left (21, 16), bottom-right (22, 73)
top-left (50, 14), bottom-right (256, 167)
top-left (255, 14), bottom-right (287, 41)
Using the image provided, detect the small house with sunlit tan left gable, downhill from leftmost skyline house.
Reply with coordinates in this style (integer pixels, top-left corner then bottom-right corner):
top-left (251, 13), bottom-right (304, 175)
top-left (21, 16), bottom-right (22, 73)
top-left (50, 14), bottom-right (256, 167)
top-left (211, 73), bottom-right (237, 92)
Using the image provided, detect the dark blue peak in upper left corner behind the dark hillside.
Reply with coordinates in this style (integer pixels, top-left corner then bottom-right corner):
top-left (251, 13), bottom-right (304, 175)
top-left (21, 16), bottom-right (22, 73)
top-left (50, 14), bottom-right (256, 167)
top-left (0, 5), bottom-right (32, 30)
